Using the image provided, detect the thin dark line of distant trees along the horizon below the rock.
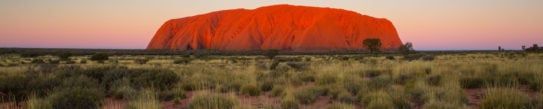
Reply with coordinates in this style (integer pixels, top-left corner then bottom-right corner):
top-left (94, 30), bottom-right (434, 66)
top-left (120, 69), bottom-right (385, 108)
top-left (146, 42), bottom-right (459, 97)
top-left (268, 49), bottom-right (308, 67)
top-left (0, 48), bottom-right (536, 57)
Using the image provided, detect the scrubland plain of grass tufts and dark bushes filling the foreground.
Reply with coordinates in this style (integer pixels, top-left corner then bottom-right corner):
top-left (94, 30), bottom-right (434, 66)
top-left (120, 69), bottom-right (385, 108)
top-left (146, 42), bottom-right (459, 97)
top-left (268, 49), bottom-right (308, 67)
top-left (0, 51), bottom-right (543, 109)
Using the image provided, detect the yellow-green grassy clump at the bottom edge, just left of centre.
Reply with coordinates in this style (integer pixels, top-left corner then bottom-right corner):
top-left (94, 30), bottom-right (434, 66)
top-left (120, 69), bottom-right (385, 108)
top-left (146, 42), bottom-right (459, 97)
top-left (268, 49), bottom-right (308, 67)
top-left (188, 93), bottom-right (237, 109)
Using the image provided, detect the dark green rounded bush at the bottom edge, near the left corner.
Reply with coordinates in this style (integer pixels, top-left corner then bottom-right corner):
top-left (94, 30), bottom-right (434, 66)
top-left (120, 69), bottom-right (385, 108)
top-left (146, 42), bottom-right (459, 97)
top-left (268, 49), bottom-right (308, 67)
top-left (48, 88), bottom-right (105, 109)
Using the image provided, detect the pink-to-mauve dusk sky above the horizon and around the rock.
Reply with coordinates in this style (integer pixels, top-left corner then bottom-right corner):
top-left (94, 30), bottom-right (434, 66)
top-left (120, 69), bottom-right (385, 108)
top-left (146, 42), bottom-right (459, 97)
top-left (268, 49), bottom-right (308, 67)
top-left (0, 0), bottom-right (543, 50)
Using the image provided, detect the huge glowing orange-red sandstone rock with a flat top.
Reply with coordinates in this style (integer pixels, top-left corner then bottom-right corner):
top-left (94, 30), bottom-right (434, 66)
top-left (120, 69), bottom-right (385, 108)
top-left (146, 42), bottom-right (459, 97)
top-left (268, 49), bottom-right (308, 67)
top-left (147, 5), bottom-right (402, 52)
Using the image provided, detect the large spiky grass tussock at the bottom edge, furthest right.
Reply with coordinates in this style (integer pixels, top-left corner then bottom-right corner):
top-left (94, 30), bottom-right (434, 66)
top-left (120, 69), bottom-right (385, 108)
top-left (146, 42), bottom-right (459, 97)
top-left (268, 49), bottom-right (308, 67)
top-left (480, 88), bottom-right (531, 109)
